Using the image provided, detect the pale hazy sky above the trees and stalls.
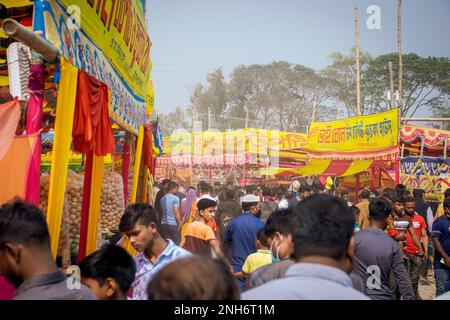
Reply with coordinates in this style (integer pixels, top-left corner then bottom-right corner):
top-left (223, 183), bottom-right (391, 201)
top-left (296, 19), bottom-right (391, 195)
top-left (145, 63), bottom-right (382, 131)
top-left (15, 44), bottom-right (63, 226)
top-left (147, 0), bottom-right (450, 116)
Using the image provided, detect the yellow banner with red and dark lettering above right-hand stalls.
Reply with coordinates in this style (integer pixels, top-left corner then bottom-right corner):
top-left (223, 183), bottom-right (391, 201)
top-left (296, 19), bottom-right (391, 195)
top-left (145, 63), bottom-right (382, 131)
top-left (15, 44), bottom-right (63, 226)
top-left (306, 109), bottom-right (399, 153)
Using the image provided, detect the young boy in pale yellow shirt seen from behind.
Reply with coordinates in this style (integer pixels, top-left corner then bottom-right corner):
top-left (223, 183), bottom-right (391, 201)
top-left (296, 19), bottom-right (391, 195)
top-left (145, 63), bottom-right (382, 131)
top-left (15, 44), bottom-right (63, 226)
top-left (234, 228), bottom-right (272, 278)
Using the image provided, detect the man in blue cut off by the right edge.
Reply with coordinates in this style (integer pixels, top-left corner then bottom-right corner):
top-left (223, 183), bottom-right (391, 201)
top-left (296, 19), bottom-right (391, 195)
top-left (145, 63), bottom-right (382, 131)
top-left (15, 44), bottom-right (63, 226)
top-left (431, 198), bottom-right (450, 296)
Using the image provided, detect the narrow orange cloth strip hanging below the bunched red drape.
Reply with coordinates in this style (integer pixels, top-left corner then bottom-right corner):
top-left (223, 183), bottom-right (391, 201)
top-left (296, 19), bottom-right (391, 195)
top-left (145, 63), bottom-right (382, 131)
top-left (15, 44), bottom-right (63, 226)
top-left (86, 154), bottom-right (104, 256)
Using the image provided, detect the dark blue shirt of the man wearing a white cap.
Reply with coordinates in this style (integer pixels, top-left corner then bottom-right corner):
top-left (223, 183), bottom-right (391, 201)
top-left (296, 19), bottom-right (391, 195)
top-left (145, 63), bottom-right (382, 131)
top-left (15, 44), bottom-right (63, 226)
top-left (224, 212), bottom-right (264, 272)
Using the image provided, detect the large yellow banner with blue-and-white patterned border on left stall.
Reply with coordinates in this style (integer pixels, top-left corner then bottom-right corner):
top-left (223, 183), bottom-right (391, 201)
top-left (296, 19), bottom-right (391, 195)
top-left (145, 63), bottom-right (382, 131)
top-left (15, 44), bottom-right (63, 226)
top-left (43, 0), bottom-right (153, 135)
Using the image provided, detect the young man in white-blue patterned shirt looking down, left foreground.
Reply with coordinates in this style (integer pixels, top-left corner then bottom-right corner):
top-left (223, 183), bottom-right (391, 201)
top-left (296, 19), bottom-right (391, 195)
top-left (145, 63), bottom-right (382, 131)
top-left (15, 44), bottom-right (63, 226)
top-left (119, 203), bottom-right (190, 300)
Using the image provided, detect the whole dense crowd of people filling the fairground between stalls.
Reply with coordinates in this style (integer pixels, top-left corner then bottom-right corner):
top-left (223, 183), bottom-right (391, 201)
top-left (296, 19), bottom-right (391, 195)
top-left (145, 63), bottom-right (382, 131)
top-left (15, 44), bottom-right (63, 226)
top-left (0, 179), bottom-right (450, 300)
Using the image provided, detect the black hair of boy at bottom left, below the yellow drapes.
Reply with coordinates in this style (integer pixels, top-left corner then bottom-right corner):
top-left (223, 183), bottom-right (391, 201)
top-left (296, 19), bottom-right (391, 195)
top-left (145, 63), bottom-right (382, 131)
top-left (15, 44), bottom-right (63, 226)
top-left (80, 244), bottom-right (136, 293)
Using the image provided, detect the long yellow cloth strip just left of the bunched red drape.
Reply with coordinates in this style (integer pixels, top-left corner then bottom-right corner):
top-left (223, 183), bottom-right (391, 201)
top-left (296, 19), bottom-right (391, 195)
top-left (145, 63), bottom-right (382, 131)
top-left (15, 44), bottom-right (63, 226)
top-left (46, 57), bottom-right (78, 257)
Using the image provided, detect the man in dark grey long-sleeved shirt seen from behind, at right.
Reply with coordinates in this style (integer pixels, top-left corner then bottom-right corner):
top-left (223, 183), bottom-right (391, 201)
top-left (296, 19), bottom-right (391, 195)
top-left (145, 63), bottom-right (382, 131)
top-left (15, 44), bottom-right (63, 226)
top-left (352, 198), bottom-right (415, 300)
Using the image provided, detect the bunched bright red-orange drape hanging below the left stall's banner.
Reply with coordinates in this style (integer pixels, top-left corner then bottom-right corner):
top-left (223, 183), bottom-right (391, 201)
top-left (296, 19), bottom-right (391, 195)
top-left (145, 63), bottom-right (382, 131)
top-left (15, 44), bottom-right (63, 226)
top-left (72, 71), bottom-right (116, 156)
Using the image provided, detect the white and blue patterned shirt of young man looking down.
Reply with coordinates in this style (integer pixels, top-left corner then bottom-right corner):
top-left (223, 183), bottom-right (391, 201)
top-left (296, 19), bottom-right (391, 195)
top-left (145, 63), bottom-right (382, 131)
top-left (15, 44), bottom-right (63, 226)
top-left (131, 239), bottom-right (191, 300)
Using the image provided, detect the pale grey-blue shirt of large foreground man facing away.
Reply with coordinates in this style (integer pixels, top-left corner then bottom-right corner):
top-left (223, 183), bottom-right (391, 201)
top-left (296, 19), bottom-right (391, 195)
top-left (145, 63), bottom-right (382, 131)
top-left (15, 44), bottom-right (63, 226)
top-left (242, 263), bottom-right (370, 300)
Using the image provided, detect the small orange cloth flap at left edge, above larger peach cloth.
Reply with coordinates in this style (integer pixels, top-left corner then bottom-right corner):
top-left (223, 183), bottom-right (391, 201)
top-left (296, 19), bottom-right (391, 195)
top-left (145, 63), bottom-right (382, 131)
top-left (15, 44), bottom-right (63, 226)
top-left (0, 100), bottom-right (20, 160)
